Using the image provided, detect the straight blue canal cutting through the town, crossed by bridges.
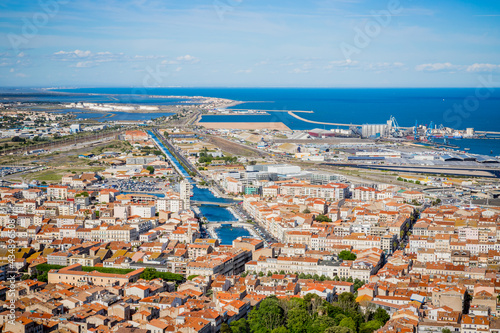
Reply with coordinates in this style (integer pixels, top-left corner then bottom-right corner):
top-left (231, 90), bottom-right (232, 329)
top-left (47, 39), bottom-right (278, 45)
top-left (148, 131), bottom-right (251, 241)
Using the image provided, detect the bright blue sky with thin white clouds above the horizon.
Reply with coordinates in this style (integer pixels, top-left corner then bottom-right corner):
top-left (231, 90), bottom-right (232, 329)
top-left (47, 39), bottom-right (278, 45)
top-left (0, 0), bottom-right (500, 87)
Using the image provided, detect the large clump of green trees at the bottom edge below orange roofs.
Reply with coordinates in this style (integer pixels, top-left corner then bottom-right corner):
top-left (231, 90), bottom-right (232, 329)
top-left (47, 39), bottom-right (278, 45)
top-left (221, 293), bottom-right (390, 333)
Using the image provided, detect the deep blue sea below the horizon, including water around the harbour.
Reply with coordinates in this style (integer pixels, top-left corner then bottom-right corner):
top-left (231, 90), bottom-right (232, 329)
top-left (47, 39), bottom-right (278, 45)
top-left (11, 88), bottom-right (500, 155)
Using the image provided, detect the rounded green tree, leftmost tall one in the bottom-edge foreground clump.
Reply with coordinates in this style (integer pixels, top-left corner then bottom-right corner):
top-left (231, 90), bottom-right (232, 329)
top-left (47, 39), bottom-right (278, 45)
top-left (248, 296), bottom-right (285, 333)
